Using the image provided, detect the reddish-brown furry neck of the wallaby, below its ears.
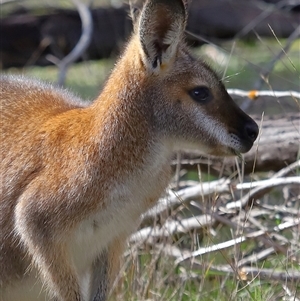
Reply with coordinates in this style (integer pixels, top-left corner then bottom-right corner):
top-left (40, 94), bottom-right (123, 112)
top-left (86, 39), bottom-right (172, 176)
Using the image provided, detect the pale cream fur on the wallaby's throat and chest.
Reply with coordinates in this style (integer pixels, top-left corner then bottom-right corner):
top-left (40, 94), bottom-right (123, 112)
top-left (69, 145), bottom-right (170, 275)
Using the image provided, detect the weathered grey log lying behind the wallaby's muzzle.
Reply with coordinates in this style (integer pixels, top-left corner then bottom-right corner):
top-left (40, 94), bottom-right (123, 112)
top-left (173, 112), bottom-right (300, 176)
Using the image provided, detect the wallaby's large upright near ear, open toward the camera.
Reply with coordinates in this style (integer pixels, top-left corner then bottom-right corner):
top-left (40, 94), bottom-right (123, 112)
top-left (136, 0), bottom-right (187, 73)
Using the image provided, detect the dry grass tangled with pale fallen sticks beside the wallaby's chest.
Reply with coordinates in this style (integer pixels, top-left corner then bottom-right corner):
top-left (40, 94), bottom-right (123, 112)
top-left (110, 162), bottom-right (300, 301)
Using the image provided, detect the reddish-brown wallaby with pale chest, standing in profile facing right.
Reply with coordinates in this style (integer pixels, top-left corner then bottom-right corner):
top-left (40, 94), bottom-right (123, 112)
top-left (0, 0), bottom-right (258, 301)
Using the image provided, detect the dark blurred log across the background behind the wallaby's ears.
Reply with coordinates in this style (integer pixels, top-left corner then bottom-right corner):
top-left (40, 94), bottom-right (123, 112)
top-left (0, 0), bottom-right (299, 68)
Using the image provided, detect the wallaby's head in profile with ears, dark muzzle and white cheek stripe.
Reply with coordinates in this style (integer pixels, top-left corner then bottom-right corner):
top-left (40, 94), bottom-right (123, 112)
top-left (125, 0), bottom-right (258, 155)
